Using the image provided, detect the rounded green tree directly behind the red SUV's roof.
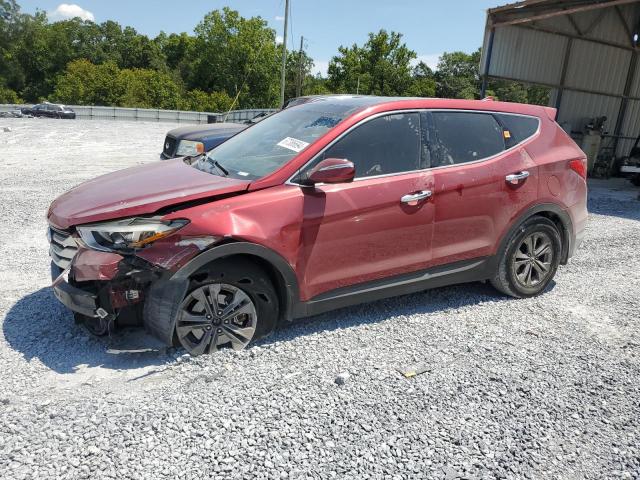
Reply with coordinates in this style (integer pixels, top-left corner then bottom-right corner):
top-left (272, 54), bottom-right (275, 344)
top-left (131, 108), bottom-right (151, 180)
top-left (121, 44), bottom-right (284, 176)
top-left (328, 29), bottom-right (416, 95)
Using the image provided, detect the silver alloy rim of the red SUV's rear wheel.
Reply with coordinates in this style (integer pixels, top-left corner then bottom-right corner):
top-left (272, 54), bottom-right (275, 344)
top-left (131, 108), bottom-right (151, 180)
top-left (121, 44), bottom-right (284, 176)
top-left (512, 232), bottom-right (553, 288)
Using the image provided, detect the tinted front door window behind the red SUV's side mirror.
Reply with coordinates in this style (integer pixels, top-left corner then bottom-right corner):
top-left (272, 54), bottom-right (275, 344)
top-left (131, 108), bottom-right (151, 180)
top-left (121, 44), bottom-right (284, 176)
top-left (321, 113), bottom-right (421, 178)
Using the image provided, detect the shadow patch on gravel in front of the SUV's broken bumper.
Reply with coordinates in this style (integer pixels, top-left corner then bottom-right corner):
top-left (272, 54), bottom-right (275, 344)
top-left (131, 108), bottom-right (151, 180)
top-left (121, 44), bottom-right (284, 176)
top-left (2, 287), bottom-right (173, 373)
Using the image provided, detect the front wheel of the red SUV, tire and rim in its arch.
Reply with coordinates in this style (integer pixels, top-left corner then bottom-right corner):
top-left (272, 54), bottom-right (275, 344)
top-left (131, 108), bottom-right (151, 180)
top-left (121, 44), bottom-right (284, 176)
top-left (175, 258), bottom-right (279, 356)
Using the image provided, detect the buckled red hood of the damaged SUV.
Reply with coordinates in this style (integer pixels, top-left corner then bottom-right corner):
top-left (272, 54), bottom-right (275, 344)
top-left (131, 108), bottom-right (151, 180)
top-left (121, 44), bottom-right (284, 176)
top-left (47, 158), bottom-right (251, 229)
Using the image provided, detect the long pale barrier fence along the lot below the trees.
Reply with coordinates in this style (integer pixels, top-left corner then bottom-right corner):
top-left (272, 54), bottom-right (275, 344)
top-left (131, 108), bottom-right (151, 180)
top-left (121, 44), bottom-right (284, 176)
top-left (0, 104), bottom-right (276, 123)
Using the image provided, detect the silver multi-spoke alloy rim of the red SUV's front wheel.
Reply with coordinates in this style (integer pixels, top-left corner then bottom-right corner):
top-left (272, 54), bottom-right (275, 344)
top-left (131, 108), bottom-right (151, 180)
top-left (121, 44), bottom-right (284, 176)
top-left (176, 283), bottom-right (257, 356)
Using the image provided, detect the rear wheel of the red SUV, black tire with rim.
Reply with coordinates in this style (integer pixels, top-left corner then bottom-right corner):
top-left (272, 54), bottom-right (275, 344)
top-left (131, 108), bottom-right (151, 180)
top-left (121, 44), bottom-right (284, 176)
top-left (491, 216), bottom-right (562, 298)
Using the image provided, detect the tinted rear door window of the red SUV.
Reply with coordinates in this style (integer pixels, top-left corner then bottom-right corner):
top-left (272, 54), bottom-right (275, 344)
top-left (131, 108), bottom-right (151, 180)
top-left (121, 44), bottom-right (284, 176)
top-left (424, 111), bottom-right (505, 167)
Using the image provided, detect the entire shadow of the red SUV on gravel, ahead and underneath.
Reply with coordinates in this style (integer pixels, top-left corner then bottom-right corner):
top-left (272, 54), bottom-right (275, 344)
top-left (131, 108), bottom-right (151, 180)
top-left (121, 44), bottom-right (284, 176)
top-left (3, 282), bottom-right (524, 373)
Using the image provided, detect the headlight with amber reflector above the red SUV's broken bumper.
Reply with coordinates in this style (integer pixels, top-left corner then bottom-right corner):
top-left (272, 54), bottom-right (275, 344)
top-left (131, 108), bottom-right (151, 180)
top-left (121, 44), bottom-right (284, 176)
top-left (77, 218), bottom-right (189, 252)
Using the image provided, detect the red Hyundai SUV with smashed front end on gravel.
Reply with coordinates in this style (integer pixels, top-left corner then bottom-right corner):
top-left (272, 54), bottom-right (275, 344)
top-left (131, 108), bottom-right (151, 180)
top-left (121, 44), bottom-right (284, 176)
top-left (48, 96), bottom-right (587, 355)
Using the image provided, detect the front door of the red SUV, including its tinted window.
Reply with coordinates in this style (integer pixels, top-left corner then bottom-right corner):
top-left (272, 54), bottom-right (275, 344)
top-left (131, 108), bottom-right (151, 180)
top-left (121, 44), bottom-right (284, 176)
top-left (296, 112), bottom-right (434, 298)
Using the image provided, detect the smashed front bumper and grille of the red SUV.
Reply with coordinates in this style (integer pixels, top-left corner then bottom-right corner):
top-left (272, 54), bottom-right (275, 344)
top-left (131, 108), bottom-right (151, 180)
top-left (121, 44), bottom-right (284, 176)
top-left (49, 223), bottom-right (217, 345)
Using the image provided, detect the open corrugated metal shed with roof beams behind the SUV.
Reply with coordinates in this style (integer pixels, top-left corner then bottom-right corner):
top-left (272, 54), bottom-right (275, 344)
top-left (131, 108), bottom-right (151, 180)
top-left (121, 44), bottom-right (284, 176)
top-left (480, 0), bottom-right (640, 161)
